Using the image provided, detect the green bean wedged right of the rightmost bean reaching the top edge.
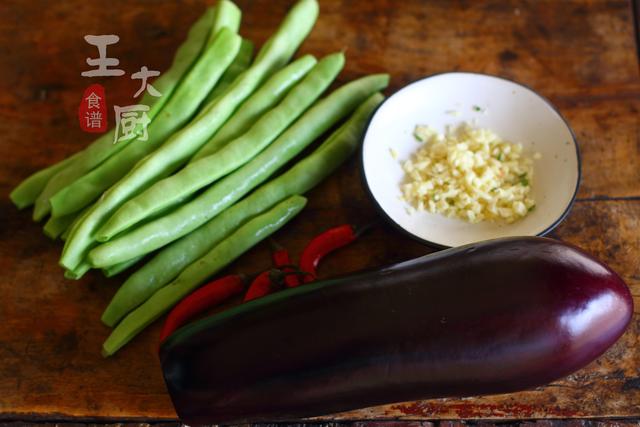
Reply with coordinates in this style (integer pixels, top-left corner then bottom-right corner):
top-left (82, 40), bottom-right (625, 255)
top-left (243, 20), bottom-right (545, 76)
top-left (190, 55), bottom-right (317, 163)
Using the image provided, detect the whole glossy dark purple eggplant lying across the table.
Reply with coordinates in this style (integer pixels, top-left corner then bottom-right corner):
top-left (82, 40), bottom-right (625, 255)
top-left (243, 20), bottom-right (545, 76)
top-left (160, 237), bottom-right (633, 425)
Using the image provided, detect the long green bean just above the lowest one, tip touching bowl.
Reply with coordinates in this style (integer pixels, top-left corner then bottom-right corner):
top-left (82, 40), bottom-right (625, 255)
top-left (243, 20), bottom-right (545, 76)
top-left (102, 93), bottom-right (384, 327)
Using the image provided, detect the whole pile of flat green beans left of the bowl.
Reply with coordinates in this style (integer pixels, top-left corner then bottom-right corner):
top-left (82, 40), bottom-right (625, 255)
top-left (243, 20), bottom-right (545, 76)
top-left (10, 0), bottom-right (389, 356)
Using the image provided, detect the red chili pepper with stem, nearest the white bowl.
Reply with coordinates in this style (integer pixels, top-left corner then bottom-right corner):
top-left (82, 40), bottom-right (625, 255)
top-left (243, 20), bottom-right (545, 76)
top-left (300, 223), bottom-right (374, 283)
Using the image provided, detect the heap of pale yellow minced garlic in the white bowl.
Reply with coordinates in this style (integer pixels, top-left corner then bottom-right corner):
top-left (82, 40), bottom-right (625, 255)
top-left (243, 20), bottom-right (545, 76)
top-left (402, 124), bottom-right (540, 223)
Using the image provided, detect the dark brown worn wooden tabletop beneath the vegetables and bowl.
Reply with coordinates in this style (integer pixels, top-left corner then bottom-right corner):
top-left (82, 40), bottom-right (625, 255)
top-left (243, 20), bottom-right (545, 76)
top-left (0, 0), bottom-right (640, 420)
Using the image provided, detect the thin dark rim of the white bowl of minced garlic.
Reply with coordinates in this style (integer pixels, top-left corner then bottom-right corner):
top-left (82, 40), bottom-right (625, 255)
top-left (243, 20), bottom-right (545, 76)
top-left (358, 71), bottom-right (582, 249)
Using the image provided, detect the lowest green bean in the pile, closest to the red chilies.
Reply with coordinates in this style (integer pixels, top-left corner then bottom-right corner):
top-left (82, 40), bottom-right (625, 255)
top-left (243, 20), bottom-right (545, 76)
top-left (102, 196), bottom-right (307, 357)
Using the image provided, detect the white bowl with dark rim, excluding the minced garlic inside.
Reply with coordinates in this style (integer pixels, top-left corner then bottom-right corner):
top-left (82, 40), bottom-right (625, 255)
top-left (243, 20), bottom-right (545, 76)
top-left (361, 72), bottom-right (580, 247)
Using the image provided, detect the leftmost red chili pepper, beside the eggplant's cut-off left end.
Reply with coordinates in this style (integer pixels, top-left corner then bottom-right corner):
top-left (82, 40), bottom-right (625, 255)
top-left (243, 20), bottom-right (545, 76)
top-left (160, 274), bottom-right (246, 342)
